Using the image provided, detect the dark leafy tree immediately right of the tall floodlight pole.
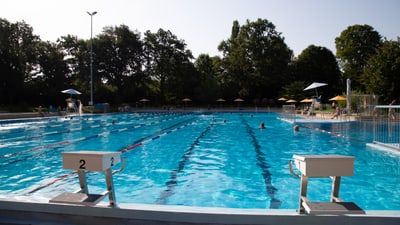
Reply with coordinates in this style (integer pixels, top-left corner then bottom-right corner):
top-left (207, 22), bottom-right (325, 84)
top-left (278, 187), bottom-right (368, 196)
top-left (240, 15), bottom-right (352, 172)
top-left (93, 25), bottom-right (146, 103)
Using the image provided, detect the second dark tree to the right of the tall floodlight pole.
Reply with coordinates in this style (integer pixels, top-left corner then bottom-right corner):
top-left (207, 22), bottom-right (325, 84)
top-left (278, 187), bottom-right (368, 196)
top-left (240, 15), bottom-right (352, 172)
top-left (144, 29), bottom-right (198, 103)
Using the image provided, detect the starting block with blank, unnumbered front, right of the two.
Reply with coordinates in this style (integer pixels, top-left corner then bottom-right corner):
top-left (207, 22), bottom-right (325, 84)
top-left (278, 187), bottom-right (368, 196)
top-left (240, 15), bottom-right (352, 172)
top-left (289, 155), bottom-right (365, 214)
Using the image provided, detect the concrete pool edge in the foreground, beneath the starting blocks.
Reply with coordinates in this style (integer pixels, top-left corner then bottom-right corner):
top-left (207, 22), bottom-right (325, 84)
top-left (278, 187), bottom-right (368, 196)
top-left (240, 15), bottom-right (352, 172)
top-left (0, 200), bottom-right (400, 225)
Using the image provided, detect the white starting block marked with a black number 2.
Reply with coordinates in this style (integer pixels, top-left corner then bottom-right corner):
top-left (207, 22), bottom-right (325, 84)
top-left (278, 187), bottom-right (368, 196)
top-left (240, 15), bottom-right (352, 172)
top-left (50, 151), bottom-right (125, 206)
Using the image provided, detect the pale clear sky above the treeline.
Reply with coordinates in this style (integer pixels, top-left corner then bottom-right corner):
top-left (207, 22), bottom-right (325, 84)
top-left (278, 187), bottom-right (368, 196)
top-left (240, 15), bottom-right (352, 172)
top-left (0, 0), bottom-right (400, 57)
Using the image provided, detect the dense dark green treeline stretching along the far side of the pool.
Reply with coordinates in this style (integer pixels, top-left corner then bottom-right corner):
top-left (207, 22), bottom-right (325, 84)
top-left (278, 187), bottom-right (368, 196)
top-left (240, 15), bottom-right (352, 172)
top-left (0, 19), bottom-right (400, 109)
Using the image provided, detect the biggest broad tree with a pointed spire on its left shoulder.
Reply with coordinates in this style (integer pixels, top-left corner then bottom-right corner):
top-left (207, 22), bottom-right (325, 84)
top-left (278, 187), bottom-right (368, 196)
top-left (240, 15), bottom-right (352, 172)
top-left (218, 19), bottom-right (292, 98)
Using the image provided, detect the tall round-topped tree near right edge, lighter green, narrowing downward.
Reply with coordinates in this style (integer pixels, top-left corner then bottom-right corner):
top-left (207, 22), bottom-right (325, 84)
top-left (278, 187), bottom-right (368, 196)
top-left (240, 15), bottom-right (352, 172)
top-left (335, 25), bottom-right (381, 91)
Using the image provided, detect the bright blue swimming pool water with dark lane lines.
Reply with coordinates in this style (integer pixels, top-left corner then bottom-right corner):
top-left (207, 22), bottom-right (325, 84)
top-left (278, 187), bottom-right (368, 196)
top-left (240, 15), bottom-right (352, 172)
top-left (0, 112), bottom-right (400, 210)
